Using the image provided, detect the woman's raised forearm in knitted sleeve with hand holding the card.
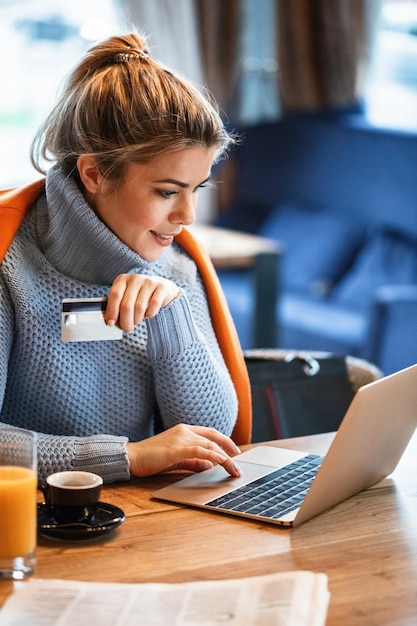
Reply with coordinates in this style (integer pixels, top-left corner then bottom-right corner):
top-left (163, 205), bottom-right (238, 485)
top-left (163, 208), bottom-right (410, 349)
top-left (106, 274), bottom-right (237, 435)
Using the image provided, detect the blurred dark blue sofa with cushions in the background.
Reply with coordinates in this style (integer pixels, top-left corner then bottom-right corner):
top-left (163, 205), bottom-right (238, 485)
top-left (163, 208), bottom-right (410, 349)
top-left (216, 114), bottom-right (417, 374)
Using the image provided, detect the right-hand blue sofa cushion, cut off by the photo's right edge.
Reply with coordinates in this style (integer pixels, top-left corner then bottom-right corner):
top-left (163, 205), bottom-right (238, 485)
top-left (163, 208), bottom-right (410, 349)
top-left (332, 231), bottom-right (417, 309)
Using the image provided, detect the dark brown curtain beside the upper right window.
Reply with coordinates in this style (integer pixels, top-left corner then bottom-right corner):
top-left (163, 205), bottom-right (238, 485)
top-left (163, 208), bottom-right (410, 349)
top-left (277, 0), bottom-right (380, 110)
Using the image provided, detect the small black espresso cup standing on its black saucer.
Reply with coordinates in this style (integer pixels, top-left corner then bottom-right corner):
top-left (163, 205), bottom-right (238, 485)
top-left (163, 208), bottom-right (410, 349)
top-left (44, 470), bottom-right (103, 524)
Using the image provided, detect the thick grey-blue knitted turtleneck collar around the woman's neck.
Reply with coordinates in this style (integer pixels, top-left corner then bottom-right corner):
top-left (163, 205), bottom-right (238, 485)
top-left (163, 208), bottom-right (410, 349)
top-left (37, 166), bottom-right (159, 284)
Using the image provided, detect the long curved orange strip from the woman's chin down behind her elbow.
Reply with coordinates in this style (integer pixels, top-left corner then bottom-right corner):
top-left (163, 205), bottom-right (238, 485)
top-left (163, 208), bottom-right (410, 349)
top-left (176, 228), bottom-right (252, 445)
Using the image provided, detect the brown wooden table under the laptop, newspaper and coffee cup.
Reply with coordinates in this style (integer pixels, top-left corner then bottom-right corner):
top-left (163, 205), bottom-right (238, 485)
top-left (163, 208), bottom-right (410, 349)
top-left (0, 434), bottom-right (417, 626)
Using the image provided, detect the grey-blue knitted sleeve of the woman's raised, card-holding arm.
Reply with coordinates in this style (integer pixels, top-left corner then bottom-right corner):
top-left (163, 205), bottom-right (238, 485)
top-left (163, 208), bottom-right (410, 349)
top-left (146, 291), bottom-right (237, 435)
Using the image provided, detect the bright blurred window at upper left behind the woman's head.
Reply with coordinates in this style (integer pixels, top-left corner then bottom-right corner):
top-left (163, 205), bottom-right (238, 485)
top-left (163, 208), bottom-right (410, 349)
top-left (0, 0), bottom-right (119, 188)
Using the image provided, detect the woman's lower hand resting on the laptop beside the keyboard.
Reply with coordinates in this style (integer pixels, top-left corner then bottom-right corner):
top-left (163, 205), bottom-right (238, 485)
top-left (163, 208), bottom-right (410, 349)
top-left (127, 424), bottom-right (241, 477)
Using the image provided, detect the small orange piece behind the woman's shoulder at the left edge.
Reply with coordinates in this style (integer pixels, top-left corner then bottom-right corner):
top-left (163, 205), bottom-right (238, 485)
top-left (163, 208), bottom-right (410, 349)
top-left (0, 179), bottom-right (45, 263)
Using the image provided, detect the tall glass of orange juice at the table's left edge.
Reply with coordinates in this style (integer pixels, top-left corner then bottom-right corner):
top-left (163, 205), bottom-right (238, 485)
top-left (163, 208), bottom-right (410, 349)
top-left (0, 426), bottom-right (37, 580)
